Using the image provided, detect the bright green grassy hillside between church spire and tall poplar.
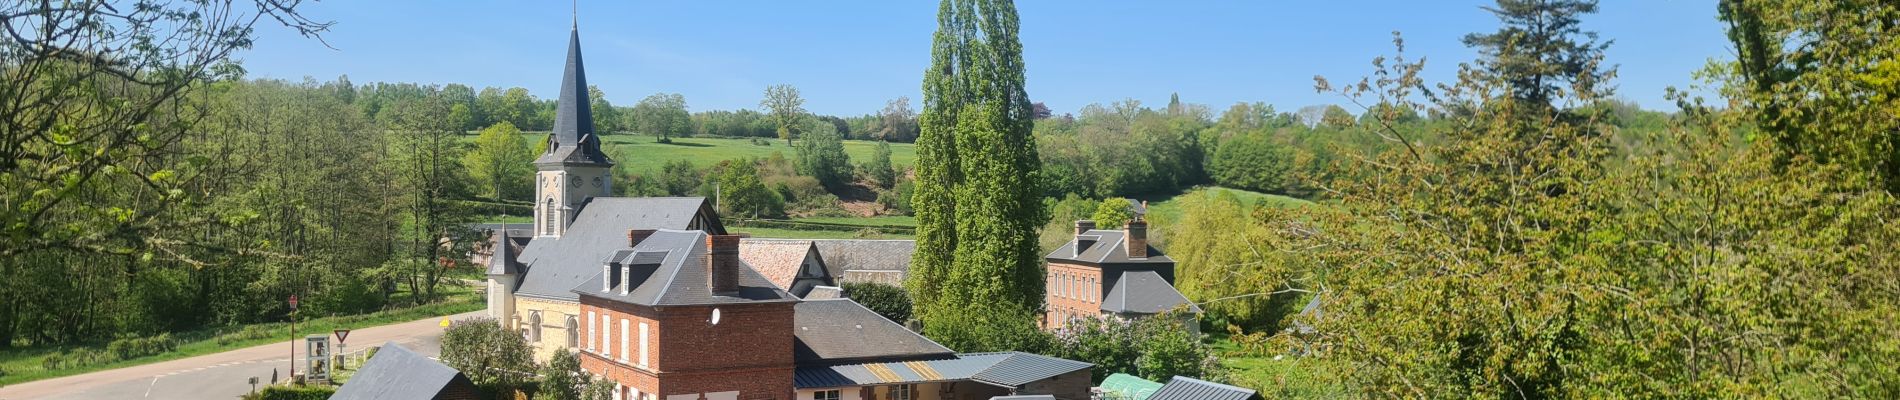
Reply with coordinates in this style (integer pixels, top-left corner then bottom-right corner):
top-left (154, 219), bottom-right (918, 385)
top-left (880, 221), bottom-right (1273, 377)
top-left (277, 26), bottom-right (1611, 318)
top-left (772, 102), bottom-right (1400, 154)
top-left (490, 133), bottom-right (918, 171)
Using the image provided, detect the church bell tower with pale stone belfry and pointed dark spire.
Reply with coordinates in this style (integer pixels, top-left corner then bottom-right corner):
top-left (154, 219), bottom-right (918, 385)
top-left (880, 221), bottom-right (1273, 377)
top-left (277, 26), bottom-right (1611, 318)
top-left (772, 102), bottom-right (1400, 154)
top-left (534, 27), bottom-right (614, 237)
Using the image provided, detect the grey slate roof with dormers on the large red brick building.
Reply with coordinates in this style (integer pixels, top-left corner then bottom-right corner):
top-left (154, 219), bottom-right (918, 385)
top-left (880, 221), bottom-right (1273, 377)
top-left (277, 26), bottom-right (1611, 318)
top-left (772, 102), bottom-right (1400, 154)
top-left (568, 229), bottom-right (798, 305)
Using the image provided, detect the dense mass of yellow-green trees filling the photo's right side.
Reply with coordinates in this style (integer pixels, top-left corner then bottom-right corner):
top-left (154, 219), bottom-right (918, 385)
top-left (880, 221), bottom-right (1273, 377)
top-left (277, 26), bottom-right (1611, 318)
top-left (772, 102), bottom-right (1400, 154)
top-left (1169, 0), bottom-right (1900, 398)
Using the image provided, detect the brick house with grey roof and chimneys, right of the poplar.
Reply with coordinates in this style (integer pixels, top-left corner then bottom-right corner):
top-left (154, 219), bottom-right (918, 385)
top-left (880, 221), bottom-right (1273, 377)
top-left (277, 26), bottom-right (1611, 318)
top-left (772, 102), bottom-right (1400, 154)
top-left (1043, 214), bottom-right (1201, 330)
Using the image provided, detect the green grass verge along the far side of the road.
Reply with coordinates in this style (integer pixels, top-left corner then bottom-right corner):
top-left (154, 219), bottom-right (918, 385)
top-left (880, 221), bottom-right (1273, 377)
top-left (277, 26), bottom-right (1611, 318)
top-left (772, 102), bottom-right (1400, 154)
top-left (0, 282), bottom-right (486, 387)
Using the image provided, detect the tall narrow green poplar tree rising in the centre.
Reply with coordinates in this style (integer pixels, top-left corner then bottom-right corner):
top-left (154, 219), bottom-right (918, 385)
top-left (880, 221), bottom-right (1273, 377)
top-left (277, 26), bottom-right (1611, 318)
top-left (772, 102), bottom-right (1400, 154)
top-left (910, 0), bottom-right (1047, 349)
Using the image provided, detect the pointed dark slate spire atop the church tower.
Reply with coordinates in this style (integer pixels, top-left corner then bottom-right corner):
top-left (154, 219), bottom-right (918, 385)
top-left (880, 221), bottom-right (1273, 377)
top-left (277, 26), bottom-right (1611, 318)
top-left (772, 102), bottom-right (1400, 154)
top-left (534, 28), bottom-right (614, 165)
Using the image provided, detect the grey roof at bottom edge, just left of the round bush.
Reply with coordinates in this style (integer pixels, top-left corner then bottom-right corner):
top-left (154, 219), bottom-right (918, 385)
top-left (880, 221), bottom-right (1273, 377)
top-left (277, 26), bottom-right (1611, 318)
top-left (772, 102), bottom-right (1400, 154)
top-left (331, 341), bottom-right (475, 400)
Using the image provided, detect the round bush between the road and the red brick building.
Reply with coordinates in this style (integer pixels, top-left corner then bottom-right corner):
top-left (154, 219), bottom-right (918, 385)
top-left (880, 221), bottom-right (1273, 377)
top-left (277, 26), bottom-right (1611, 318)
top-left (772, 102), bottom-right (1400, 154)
top-left (443, 317), bottom-right (534, 392)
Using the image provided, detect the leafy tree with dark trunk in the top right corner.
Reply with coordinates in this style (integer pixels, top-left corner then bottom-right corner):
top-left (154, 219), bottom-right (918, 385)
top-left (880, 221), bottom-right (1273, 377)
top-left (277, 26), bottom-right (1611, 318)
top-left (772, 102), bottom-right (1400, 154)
top-left (1712, 0), bottom-right (1900, 191)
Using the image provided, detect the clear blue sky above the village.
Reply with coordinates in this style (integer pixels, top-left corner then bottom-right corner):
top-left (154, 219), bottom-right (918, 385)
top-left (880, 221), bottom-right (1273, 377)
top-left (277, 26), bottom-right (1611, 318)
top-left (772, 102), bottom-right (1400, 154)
top-left (239, 0), bottom-right (1733, 116)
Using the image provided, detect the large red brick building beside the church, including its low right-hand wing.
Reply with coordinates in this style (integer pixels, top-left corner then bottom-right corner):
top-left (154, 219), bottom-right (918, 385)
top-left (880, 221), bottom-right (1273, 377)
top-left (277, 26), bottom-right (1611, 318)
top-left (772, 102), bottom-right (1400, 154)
top-left (574, 229), bottom-right (1093, 400)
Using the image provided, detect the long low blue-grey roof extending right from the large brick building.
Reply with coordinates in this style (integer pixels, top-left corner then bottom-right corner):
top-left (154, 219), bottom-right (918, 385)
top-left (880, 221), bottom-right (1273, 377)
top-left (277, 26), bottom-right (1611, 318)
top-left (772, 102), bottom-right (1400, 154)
top-left (792, 351), bottom-right (1094, 389)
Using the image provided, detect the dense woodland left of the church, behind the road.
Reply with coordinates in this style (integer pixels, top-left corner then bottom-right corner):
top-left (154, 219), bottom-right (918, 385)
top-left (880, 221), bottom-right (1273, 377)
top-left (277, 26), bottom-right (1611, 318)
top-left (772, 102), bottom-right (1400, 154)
top-left (0, 2), bottom-right (490, 347)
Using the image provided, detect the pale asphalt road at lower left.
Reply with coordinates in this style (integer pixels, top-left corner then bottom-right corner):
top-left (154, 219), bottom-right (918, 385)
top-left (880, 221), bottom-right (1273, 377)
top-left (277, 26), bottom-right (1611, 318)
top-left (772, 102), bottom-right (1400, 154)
top-left (0, 311), bottom-right (483, 400)
